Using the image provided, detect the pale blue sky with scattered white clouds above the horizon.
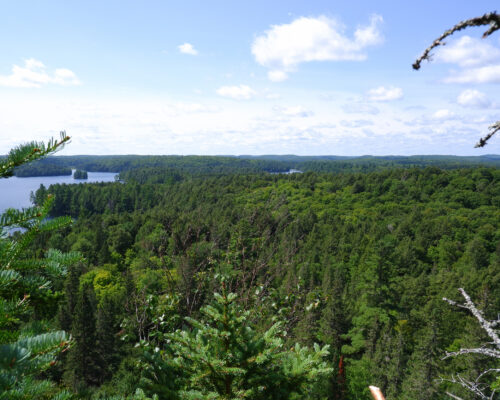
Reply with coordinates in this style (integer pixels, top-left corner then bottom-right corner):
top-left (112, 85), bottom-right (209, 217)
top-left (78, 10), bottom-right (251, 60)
top-left (0, 0), bottom-right (500, 156)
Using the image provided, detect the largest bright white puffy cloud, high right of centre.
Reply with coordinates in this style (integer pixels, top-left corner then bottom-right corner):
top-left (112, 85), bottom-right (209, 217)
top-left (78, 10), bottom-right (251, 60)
top-left (252, 15), bottom-right (383, 81)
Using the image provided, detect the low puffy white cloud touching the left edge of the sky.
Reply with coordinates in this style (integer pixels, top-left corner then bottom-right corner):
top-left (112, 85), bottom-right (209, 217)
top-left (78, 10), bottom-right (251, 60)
top-left (0, 58), bottom-right (81, 88)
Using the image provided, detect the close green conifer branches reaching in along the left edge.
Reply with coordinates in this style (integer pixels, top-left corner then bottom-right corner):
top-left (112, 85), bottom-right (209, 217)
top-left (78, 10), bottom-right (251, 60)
top-left (0, 132), bottom-right (80, 400)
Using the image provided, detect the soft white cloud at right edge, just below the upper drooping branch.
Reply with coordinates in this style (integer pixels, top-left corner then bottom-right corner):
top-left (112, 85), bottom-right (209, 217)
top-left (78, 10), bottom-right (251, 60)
top-left (435, 36), bottom-right (500, 67)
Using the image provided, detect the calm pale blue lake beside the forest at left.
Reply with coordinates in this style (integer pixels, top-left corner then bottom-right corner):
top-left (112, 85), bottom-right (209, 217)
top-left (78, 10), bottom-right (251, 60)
top-left (0, 172), bottom-right (117, 214)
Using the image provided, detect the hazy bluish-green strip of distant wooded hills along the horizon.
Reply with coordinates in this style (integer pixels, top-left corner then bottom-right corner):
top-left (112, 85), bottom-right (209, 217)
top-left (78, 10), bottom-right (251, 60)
top-left (9, 155), bottom-right (500, 176)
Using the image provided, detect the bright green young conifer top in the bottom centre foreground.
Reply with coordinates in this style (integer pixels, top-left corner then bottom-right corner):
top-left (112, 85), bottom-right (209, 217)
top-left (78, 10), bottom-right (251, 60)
top-left (143, 283), bottom-right (331, 400)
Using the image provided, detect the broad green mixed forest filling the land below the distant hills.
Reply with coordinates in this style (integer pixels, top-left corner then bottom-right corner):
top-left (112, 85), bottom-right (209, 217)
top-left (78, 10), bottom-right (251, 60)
top-left (11, 158), bottom-right (500, 400)
